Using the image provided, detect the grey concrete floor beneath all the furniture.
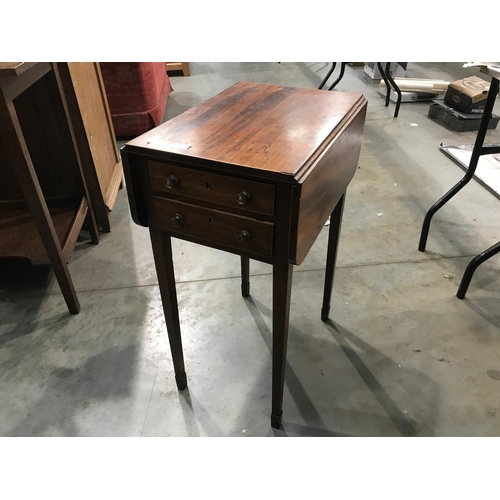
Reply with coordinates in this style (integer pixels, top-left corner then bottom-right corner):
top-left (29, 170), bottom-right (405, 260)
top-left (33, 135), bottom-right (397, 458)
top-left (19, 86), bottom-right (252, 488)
top-left (0, 63), bottom-right (500, 437)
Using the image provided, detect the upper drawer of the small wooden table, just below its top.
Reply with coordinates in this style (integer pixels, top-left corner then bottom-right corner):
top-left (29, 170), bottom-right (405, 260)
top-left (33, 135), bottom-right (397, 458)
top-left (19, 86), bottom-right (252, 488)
top-left (149, 161), bottom-right (274, 215)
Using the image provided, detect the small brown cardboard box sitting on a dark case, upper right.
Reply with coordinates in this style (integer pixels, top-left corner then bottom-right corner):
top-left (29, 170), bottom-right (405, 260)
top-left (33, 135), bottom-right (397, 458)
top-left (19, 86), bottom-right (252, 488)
top-left (444, 76), bottom-right (490, 113)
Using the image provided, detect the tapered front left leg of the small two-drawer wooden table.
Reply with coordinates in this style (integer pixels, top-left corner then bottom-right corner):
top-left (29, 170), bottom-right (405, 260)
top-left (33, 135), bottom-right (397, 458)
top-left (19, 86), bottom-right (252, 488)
top-left (149, 229), bottom-right (187, 390)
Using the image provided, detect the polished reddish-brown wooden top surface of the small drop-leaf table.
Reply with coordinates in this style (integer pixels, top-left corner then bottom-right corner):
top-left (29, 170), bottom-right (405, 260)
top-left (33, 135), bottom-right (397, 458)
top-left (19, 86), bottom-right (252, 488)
top-left (127, 82), bottom-right (365, 180)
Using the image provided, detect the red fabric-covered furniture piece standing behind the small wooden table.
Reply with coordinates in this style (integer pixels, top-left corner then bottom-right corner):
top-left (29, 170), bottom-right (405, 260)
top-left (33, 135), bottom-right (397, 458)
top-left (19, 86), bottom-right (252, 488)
top-left (100, 62), bottom-right (173, 137)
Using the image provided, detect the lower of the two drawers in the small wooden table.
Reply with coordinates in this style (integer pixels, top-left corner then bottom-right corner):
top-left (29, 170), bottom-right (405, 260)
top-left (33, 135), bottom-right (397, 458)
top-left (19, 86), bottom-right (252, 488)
top-left (154, 196), bottom-right (274, 257)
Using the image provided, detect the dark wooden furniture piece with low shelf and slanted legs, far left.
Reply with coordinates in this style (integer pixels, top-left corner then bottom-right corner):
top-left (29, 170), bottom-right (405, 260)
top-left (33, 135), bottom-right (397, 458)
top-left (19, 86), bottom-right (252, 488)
top-left (0, 62), bottom-right (99, 314)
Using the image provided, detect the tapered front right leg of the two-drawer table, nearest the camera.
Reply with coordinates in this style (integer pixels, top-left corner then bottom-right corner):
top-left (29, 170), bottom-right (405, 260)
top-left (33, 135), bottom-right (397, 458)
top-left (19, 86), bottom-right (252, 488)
top-left (271, 262), bottom-right (293, 429)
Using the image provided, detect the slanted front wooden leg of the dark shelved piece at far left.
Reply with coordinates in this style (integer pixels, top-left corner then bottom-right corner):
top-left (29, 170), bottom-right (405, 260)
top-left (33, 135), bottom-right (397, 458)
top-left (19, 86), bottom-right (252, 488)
top-left (0, 98), bottom-right (80, 314)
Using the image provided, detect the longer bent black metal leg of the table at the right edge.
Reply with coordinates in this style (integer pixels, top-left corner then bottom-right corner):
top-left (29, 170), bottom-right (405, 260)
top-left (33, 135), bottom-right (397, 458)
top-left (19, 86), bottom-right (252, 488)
top-left (418, 78), bottom-right (498, 252)
